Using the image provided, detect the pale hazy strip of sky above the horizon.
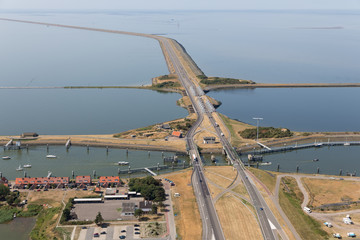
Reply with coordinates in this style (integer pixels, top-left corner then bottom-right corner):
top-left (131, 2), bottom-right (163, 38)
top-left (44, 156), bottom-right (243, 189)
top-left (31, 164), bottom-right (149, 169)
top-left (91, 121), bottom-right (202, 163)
top-left (0, 0), bottom-right (360, 10)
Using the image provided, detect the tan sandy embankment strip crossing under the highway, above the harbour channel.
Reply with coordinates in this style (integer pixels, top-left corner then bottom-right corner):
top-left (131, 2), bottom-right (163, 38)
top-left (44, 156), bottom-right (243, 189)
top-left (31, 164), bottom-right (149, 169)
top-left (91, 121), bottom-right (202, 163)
top-left (0, 132), bottom-right (360, 154)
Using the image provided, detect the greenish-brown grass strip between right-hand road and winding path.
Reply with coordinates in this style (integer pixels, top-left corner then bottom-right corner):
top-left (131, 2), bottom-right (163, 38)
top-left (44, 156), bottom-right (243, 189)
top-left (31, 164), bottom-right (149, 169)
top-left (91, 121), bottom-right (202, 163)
top-left (279, 177), bottom-right (329, 240)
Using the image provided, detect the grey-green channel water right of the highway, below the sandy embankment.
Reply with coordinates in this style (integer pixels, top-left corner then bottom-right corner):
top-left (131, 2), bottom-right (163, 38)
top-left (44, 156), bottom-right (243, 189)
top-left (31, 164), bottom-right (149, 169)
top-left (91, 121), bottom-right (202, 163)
top-left (253, 143), bottom-right (360, 175)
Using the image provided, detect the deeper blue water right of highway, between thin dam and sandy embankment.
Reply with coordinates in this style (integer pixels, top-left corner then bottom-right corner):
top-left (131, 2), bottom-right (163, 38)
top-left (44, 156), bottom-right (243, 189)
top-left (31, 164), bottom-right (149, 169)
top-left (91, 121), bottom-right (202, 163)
top-left (208, 88), bottom-right (360, 132)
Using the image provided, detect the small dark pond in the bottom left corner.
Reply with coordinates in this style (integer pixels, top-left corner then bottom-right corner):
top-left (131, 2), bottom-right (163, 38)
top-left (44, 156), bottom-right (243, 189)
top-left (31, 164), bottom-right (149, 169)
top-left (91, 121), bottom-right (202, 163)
top-left (0, 218), bottom-right (36, 240)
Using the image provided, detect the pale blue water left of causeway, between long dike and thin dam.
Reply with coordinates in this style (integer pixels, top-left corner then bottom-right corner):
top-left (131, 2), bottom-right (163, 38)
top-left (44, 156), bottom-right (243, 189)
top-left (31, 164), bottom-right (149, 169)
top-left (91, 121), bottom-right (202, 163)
top-left (0, 19), bottom-right (168, 86)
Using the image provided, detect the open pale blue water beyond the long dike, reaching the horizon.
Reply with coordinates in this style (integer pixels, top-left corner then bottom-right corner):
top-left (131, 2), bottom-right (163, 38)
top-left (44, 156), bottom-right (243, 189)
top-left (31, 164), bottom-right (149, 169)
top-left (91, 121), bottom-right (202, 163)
top-left (1, 10), bottom-right (360, 82)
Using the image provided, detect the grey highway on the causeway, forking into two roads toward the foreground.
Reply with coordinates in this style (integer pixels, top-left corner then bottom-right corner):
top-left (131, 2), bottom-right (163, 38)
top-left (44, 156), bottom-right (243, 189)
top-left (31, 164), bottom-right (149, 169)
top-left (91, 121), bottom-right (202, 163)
top-left (159, 38), bottom-right (280, 240)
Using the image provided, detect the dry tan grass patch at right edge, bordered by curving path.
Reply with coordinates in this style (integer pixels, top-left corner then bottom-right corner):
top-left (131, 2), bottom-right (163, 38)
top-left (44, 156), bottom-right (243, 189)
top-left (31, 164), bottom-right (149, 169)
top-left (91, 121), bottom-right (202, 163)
top-left (303, 178), bottom-right (360, 207)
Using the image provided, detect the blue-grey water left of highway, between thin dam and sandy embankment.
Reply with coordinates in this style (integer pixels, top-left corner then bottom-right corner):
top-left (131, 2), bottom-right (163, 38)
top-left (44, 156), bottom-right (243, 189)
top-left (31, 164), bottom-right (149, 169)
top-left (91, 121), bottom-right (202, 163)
top-left (0, 89), bottom-right (187, 135)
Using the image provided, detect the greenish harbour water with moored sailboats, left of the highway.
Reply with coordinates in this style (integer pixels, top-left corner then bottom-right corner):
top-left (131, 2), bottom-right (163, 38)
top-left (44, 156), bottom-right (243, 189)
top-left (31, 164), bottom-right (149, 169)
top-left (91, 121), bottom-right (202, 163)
top-left (0, 145), bottom-right (189, 179)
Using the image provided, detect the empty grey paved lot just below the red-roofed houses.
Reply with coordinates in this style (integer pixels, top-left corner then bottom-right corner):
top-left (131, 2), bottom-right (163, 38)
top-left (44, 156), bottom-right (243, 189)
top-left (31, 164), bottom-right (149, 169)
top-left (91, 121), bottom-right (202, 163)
top-left (72, 198), bottom-right (143, 220)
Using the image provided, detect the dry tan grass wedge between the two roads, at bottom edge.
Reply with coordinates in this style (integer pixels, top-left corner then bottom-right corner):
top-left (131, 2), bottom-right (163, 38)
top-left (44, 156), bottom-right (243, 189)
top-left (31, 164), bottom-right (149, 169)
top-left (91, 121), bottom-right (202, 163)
top-left (215, 193), bottom-right (262, 240)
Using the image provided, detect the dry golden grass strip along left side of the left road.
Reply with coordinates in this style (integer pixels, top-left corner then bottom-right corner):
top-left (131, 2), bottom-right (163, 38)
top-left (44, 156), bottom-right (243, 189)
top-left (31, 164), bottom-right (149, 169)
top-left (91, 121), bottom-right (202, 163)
top-left (169, 169), bottom-right (202, 240)
